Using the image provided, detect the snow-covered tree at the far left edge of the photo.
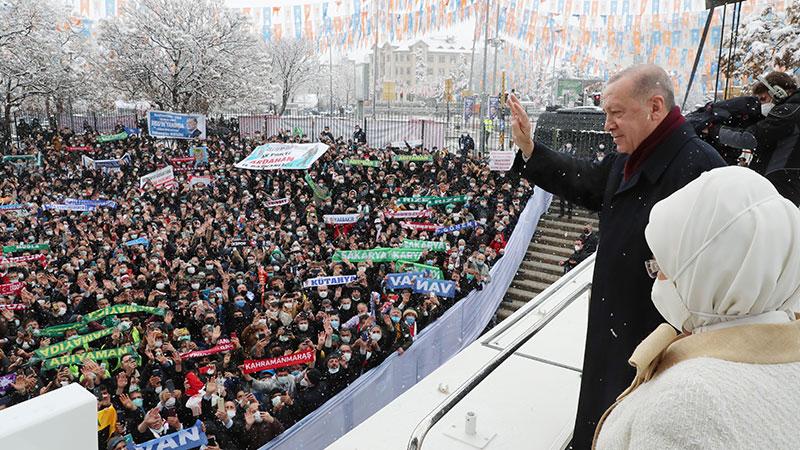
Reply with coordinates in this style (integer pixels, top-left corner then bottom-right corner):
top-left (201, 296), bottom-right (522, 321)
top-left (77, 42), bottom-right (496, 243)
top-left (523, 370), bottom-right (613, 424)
top-left (0, 0), bottom-right (86, 136)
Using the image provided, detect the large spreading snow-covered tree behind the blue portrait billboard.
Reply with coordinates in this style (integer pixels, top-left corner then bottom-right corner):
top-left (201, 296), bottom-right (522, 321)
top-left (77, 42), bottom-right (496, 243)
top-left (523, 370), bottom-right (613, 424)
top-left (99, 0), bottom-right (267, 112)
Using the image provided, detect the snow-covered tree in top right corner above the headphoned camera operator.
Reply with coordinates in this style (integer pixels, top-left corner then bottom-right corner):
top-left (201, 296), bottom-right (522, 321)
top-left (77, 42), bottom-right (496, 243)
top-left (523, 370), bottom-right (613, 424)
top-left (722, 0), bottom-right (800, 78)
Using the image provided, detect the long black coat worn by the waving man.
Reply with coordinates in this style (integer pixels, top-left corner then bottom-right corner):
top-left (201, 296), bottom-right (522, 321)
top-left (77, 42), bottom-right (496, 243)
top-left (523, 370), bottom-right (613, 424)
top-left (512, 123), bottom-right (725, 449)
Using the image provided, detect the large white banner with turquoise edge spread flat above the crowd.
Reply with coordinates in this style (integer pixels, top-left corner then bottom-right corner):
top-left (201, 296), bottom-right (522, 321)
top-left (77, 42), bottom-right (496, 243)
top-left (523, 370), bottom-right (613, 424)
top-left (236, 142), bottom-right (329, 170)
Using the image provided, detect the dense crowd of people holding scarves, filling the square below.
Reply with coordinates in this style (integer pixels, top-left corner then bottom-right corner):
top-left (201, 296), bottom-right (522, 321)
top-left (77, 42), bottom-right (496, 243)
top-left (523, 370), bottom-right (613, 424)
top-left (0, 118), bottom-right (532, 450)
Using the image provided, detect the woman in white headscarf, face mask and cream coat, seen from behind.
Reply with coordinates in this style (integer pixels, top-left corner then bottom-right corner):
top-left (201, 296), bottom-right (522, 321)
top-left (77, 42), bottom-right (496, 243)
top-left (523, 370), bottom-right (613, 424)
top-left (595, 167), bottom-right (800, 449)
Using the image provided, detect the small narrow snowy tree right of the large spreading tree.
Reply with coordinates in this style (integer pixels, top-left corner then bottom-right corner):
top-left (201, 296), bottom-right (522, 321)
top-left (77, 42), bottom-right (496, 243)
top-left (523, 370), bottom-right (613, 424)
top-left (267, 38), bottom-right (320, 116)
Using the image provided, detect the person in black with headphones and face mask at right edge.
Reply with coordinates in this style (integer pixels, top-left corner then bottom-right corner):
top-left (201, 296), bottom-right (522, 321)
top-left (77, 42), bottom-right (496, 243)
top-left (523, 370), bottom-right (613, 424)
top-left (709, 72), bottom-right (800, 205)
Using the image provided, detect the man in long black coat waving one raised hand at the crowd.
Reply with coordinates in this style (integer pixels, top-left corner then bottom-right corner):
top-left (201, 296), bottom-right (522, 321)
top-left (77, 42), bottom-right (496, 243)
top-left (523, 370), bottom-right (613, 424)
top-left (509, 65), bottom-right (725, 449)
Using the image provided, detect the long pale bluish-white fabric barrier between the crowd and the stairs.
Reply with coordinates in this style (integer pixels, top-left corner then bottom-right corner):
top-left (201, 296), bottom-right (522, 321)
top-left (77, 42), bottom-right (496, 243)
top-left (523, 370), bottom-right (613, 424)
top-left (260, 187), bottom-right (552, 450)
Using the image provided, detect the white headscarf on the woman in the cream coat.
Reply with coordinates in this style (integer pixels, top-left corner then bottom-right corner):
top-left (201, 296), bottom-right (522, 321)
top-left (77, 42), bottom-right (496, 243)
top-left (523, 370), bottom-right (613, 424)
top-left (645, 166), bottom-right (800, 331)
